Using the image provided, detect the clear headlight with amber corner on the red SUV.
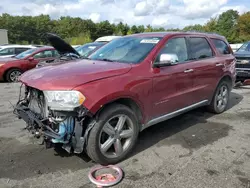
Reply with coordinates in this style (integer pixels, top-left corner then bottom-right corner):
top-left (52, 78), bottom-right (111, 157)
top-left (44, 90), bottom-right (86, 111)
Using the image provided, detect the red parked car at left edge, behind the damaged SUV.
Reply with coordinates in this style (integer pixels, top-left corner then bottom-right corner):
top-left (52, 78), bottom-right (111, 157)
top-left (0, 47), bottom-right (59, 82)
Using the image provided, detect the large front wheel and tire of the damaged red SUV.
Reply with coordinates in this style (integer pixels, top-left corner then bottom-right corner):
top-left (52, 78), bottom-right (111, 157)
top-left (86, 104), bottom-right (139, 165)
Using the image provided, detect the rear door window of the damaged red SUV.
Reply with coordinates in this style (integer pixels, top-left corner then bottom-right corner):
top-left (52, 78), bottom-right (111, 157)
top-left (189, 37), bottom-right (213, 60)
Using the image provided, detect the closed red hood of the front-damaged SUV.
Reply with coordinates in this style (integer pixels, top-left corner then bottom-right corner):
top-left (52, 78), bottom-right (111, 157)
top-left (20, 60), bottom-right (132, 90)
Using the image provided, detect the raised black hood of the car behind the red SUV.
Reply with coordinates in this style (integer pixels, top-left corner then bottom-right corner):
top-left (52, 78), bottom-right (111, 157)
top-left (46, 33), bottom-right (80, 56)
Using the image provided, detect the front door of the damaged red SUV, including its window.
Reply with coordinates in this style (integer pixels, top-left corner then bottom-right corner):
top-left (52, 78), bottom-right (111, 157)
top-left (149, 37), bottom-right (193, 119)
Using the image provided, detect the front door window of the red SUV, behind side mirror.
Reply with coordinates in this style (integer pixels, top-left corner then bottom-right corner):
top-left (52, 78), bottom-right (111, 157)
top-left (156, 38), bottom-right (188, 63)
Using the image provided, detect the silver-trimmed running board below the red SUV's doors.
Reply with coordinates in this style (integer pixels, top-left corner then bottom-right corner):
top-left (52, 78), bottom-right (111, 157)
top-left (141, 100), bottom-right (208, 131)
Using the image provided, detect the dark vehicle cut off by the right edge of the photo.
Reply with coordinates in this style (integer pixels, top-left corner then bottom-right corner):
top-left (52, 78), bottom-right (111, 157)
top-left (234, 41), bottom-right (250, 82)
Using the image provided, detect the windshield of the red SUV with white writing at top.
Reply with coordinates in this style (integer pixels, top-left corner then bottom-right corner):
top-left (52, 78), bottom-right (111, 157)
top-left (89, 37), bottom-right (162, 64)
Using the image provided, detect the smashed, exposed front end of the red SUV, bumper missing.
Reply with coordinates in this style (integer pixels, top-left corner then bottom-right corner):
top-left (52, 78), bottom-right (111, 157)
top-left (14, 85), bottom-right (95, 153)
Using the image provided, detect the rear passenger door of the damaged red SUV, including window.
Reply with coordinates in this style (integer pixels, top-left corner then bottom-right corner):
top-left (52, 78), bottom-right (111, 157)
top-left (188, 37), bottom-right (223, 103)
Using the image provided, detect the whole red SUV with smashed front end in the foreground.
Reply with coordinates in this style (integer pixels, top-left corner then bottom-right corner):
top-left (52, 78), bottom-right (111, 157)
top-left (15, 32), bottom-right (236, 164)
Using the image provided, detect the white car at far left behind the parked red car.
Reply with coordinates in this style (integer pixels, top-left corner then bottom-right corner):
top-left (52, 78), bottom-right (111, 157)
top-left (0, 44), bottom-right (37, 58)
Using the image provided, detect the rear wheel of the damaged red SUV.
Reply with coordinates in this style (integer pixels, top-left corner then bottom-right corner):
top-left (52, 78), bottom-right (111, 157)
top-left (208, 81), bottom-right (231, 114)
